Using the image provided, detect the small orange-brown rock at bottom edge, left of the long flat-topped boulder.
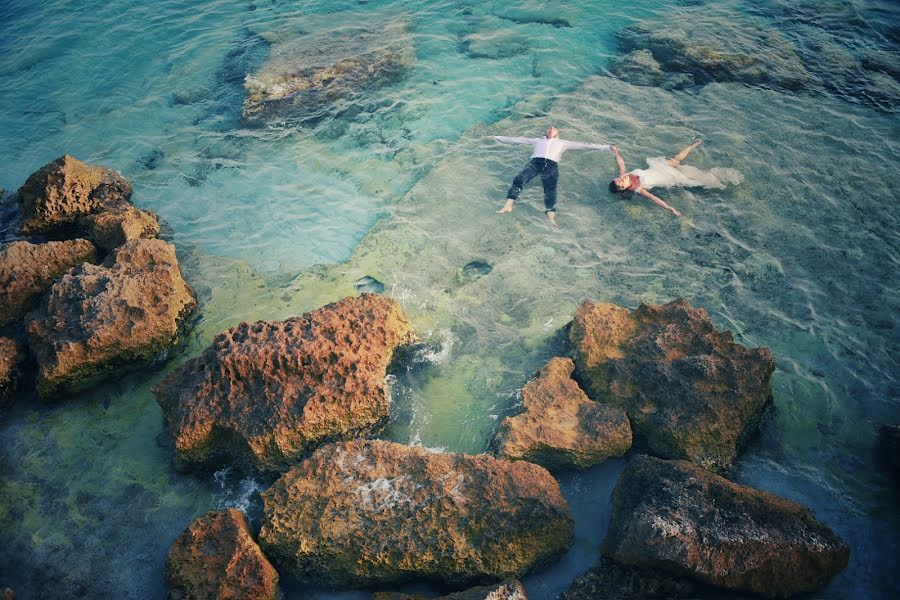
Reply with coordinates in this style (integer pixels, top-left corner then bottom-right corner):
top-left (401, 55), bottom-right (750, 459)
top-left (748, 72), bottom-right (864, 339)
top-left (166, 508), bottom-right (278, 600)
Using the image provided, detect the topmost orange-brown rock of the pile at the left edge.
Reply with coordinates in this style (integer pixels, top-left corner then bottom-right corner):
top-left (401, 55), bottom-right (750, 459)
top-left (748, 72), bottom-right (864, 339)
top-left (19, 154), bottom-right (132, 235)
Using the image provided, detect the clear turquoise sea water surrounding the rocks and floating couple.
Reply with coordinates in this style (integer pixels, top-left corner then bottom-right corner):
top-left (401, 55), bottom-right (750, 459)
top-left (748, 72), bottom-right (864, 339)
top-left (0, 0), bottom-right (900, 599)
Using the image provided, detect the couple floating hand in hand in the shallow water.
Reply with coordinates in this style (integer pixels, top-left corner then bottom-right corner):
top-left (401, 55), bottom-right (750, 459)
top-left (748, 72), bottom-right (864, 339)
top-left (493, 126), bottom-right (743, 225)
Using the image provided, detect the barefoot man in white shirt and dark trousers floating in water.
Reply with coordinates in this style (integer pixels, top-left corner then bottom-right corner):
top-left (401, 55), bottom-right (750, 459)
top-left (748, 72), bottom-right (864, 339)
top-left (494, 126), bottom-right (614, 226)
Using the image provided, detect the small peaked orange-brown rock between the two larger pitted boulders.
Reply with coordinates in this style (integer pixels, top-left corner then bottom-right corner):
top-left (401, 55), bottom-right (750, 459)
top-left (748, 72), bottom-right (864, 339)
top-left (493, 358), bottom-right (631, 469)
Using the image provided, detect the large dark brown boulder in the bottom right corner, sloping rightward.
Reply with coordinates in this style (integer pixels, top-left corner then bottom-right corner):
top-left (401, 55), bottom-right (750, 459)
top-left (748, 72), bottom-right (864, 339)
top-left (603, 455), bottom-right (850, 598)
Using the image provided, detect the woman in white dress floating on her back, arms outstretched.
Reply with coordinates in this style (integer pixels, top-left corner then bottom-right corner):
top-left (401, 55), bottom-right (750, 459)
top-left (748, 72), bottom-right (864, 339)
top-left (609, 140), bottom-right (744, 217)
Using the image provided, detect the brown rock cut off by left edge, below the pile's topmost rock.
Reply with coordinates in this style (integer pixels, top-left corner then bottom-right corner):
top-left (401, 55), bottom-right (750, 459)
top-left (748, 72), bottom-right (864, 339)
top-left (0, 240), bottom-right (97, 327)
